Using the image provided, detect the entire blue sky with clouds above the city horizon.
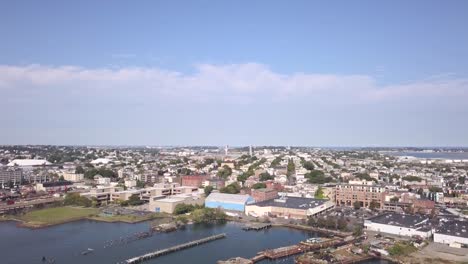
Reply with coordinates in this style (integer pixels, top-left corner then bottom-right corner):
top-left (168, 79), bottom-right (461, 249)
top-left (0, 0), bottom-right (468, 146)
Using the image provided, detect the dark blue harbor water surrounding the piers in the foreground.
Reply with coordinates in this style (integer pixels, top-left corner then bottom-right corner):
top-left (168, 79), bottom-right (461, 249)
top-left (0, 221), bottom-right (386, 264)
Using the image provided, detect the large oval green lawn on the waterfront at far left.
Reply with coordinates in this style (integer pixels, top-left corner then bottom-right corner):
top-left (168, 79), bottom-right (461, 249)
top-left (17, 206), bottom-right (99, 227)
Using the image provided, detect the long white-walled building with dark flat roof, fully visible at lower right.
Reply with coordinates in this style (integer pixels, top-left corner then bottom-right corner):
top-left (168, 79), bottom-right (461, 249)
top-left (364, 213), bottom-right (432, 239)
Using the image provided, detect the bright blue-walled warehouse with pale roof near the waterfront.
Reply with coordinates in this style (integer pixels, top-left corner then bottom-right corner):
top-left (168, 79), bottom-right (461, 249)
top-left (205, 193), bottom-right (254, 212)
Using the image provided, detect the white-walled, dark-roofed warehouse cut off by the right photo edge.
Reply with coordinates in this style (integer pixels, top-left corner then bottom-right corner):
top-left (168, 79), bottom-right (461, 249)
top-left (434, 220), bottom-right (468, 247)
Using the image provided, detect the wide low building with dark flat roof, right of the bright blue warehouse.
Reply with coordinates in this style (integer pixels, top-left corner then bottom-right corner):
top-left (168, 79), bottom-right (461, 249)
top-left (245, 197), bottom-right (335, 219)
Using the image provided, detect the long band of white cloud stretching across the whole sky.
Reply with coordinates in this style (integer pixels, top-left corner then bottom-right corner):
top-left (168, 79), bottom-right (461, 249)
top-left (0, 63), bottom-right (468, 104)
